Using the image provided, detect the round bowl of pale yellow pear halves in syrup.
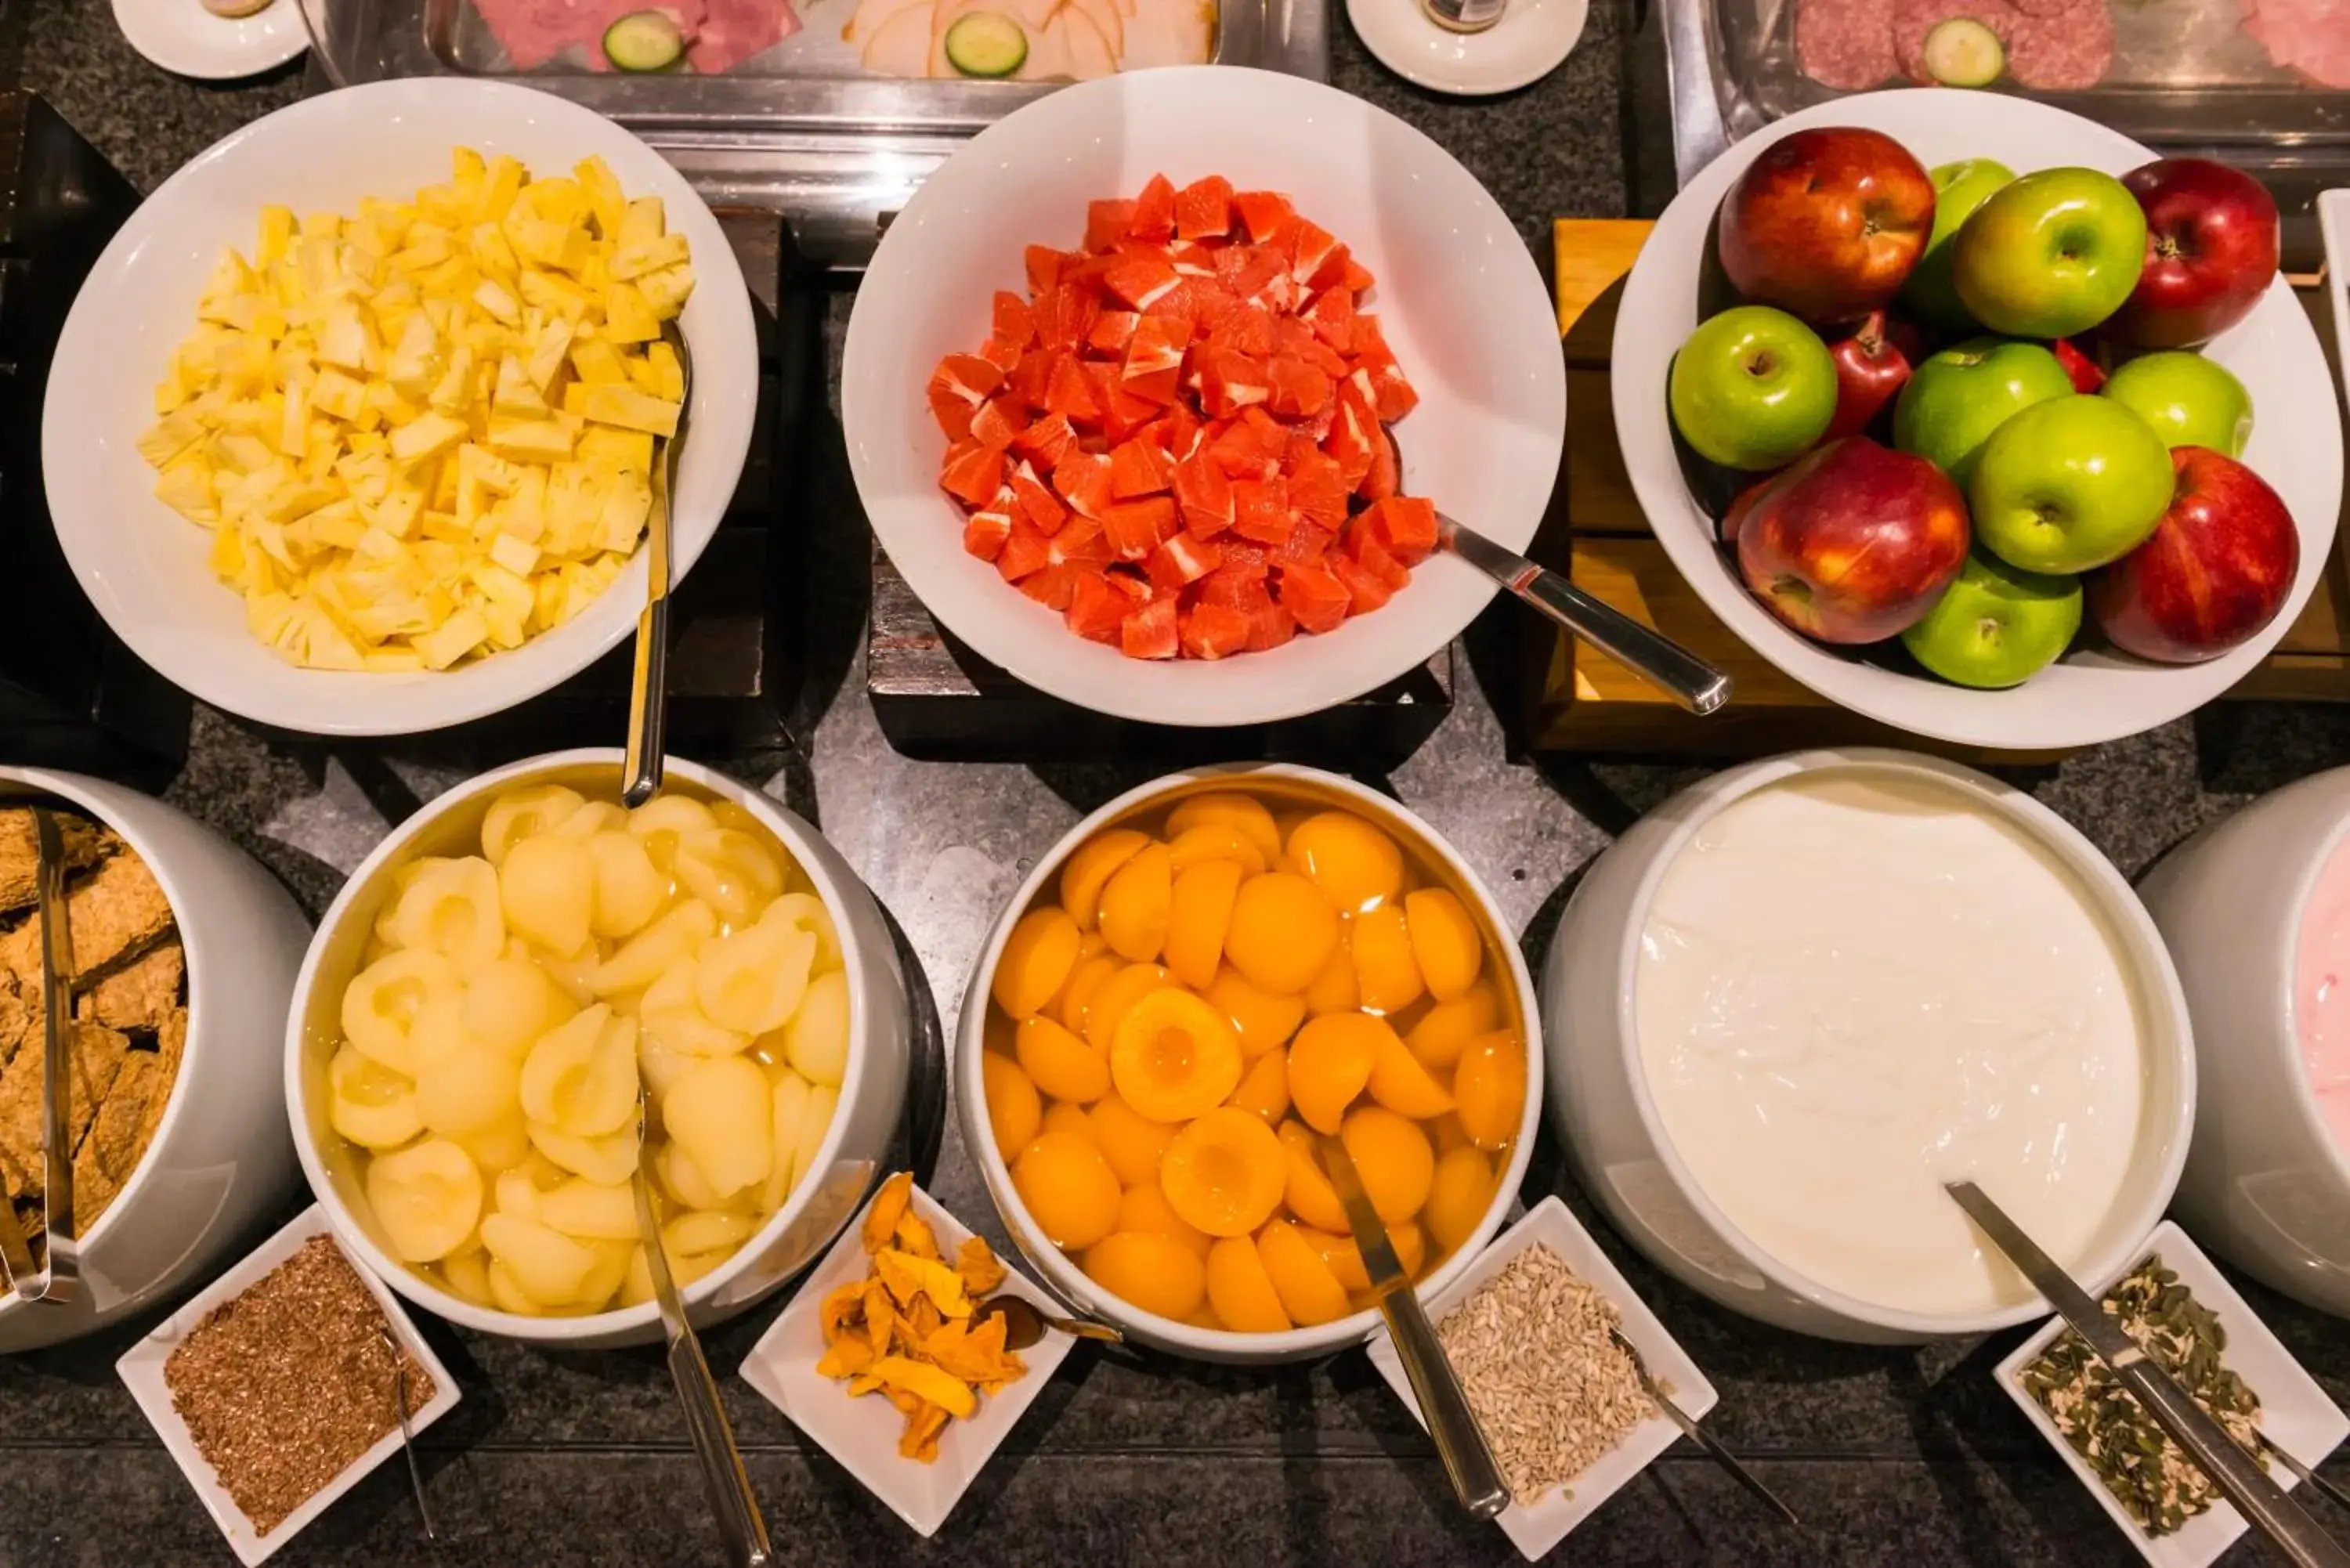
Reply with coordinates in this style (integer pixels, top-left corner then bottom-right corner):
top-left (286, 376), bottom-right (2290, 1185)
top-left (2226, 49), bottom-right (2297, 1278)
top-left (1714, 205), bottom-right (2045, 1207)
top-left (287, 750), bottom-right (912, 1347)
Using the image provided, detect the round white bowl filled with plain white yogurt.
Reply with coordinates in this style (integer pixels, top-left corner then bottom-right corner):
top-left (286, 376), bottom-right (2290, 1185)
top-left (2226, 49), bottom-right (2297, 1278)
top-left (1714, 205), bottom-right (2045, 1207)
top-left (1542, 747), bottom-right (2195, 1342)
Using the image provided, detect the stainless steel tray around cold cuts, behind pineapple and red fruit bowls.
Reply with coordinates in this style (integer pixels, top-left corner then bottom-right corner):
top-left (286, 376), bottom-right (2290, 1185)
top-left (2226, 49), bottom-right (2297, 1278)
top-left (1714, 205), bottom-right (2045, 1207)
top-left (301, 0), bottom-right (1330, 266)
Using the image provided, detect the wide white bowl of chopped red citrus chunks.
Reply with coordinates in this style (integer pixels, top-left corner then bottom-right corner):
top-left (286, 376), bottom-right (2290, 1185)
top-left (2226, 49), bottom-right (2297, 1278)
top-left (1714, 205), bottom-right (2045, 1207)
top-left (841, 66), bottom-right (1567, 726)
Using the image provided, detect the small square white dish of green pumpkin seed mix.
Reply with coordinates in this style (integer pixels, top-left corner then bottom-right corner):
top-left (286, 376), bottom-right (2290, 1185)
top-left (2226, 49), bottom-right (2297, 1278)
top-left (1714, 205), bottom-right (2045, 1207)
top-left (1998, 1220), bottom-right (2350, 1568)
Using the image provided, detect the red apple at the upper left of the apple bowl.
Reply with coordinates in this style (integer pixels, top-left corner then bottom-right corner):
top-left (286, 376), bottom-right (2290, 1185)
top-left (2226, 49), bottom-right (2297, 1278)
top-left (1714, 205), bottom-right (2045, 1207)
top-left (1720, 127), bottom-right (1934, 322)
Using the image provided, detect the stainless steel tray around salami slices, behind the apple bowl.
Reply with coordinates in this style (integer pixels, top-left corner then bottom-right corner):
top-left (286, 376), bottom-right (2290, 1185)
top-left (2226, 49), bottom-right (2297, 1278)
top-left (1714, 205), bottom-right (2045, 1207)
top-left (1654, 0), bottom-right (2350, 266)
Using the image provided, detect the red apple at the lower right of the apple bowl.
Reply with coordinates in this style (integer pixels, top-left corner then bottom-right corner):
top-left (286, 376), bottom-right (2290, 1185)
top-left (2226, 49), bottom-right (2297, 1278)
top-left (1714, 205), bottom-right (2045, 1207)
top-left (2089, 446), bottom-right (2301, 665)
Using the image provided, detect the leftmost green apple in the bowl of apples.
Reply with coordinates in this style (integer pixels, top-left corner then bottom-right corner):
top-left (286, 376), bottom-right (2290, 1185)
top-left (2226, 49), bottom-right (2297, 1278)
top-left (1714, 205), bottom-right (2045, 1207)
top-left (1671, 305), bottom-right (1835, 472)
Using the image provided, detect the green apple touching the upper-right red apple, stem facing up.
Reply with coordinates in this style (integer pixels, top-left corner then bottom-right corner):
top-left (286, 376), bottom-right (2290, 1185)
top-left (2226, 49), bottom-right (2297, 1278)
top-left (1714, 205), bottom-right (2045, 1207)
top-left (1950, 169), bottom-right (2146, 338)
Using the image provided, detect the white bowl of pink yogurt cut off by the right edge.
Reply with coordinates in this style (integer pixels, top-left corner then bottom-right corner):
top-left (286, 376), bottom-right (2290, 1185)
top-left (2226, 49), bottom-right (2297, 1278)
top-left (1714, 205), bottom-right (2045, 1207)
top-left (2138, 768), bottom-right (2350, 1317)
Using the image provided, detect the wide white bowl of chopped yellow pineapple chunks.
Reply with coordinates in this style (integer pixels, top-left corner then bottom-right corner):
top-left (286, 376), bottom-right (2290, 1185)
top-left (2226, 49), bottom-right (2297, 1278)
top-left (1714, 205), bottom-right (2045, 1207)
top-left (42, 78), bottom-right (759, 735)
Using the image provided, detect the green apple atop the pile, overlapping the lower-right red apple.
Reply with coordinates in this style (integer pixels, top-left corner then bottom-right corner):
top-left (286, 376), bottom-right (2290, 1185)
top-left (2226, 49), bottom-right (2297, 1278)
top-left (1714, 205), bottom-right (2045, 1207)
top-left (1967, 392), bottom-right (2171, 573)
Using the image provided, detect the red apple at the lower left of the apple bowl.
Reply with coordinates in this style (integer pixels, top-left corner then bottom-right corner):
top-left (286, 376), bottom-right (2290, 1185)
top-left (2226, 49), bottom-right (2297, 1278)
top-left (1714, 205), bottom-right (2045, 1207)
top-left (1739, 435), bottom-right (1972, 641)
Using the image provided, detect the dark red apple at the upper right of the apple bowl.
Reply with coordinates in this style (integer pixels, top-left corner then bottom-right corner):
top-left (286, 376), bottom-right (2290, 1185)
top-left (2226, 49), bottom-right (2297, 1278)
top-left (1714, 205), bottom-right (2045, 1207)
top-left (2103, 157), bottom-right (2280, 348)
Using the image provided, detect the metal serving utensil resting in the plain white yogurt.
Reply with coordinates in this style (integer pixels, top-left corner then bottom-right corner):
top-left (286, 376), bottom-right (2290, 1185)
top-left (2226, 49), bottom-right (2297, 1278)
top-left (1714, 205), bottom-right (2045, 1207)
top-left (1943, 1183), bottom-right (2350, 1568)
